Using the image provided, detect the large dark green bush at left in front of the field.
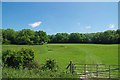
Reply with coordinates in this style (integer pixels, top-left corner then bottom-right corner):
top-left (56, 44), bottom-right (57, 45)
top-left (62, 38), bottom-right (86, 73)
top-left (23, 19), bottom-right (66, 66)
top-left (2, 48), bottom-right (34, 68)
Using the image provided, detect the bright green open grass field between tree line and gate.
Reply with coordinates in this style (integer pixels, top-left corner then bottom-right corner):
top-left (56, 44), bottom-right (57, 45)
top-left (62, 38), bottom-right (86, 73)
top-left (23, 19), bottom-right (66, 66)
top-left (2, 44), bottom-right (118, 70)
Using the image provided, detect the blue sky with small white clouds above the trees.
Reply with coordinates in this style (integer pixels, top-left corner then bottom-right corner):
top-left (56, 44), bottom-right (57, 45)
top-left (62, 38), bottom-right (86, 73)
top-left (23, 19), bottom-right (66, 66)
top-left (2, 2), bottom-right (118, 34)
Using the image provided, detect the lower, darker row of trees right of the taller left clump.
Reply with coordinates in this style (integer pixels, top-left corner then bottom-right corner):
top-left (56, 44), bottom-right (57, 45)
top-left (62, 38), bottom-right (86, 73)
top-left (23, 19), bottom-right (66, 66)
top-left (48, 29), bottom-right (120, 44)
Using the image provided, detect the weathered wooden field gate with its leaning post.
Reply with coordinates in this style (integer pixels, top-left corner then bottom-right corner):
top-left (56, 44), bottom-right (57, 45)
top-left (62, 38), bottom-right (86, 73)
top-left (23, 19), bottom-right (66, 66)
top-left (66, 61), bottom-right (120, 79)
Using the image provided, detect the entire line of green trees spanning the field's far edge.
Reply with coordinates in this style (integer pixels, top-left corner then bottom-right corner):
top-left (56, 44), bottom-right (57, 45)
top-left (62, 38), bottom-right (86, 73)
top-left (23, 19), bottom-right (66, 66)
top-left (1, 29), bottom-right (120, 45)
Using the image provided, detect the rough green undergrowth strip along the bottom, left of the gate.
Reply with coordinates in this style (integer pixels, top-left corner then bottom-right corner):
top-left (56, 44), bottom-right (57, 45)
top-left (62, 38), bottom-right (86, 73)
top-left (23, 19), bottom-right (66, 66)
top-left (2, 68), bottom-right (72, 80)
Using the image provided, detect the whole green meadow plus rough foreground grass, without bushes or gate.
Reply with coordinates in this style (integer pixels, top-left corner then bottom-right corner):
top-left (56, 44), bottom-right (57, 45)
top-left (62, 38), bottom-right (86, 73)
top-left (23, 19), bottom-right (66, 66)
top-left (2, 44), bottom-right (118, 78)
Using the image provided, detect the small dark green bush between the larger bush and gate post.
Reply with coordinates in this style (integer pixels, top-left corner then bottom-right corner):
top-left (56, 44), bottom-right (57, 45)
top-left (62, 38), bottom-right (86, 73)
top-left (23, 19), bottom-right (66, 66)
top-left (42, 59), bottom-right (58, 71)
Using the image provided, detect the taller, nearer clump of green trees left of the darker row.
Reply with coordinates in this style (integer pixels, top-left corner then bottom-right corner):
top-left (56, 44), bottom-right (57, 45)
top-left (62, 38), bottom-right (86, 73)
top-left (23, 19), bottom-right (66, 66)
top-left (2, 29), bottom-right (48, 45)
